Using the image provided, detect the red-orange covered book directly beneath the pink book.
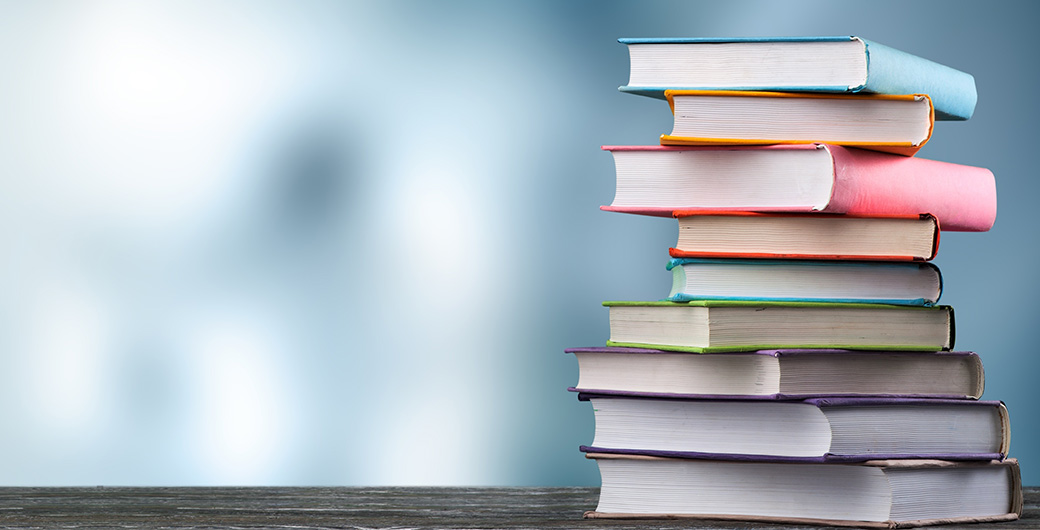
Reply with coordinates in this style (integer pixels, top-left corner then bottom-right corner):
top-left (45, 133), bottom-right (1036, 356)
top-left (669, 210), bottom-right (939, 261)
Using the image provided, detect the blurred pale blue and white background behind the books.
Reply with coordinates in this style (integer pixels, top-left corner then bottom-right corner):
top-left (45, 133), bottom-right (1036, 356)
top-left (0, 0), bottom-right (1040, 485)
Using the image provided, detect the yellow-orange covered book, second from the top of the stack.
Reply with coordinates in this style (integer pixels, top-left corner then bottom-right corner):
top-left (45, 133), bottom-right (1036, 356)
top-left (660, 90), bottom-right (935, 156)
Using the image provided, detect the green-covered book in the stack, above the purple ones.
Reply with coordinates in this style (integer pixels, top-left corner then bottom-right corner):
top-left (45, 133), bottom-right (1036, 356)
top-left (603, 300), bottom-right (955, 352)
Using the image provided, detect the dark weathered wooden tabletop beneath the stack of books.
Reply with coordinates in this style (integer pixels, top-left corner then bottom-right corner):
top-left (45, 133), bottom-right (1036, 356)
top-left (0, 487), bottom-right (1040, 530)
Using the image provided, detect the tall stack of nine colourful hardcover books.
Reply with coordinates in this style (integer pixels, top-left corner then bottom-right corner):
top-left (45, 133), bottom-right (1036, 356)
top-left (568, 37), bottom-right (1022, 527)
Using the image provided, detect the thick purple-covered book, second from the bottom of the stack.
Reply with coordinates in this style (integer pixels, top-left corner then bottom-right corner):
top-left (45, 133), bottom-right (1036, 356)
top-left (578, 393), bottom-right (1011, 461)
